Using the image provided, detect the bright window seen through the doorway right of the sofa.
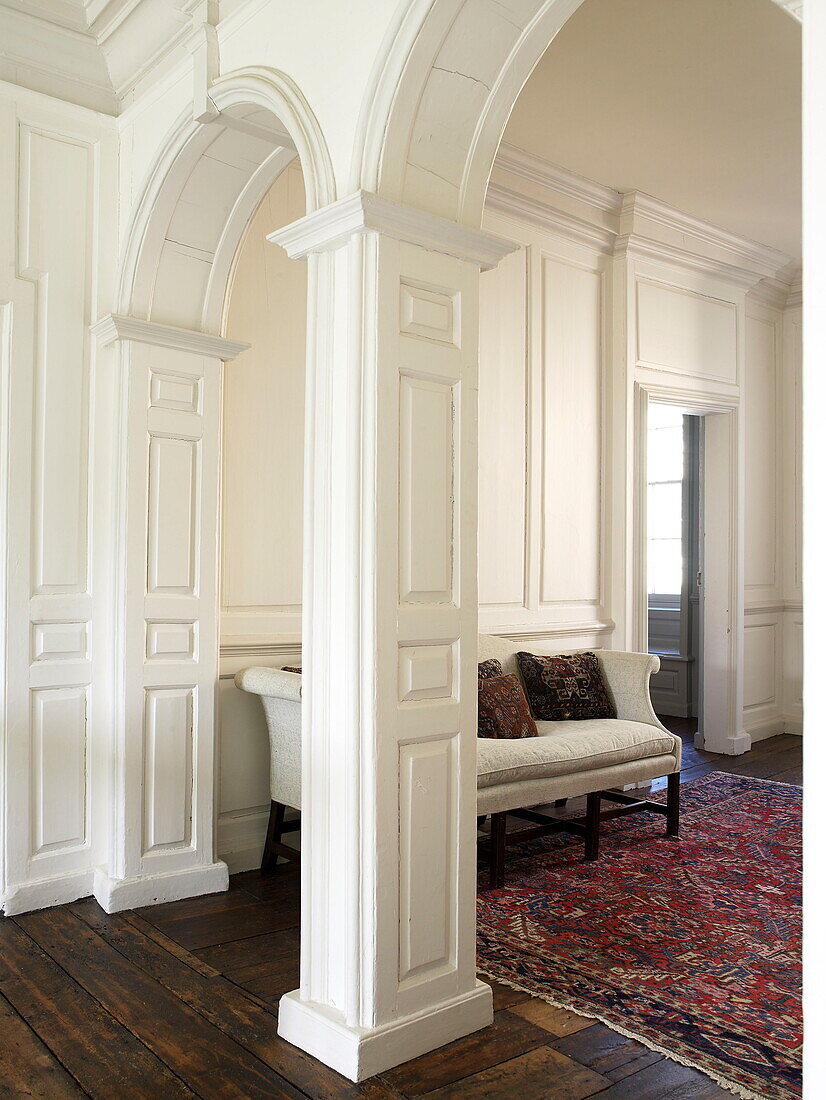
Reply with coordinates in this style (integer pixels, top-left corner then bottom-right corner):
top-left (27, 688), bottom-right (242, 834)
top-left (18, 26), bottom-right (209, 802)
top-left (648, 404), bottom-right (684, 607)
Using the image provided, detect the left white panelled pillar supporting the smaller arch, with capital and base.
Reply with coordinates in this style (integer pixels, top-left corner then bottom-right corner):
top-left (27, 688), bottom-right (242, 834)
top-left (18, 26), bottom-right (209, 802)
top-left (93, 316), bottom-right (245, 912)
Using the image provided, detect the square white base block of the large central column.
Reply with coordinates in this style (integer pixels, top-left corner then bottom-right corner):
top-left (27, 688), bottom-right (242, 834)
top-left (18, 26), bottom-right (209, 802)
top-left (278, 981), bottom-right (493, 1081)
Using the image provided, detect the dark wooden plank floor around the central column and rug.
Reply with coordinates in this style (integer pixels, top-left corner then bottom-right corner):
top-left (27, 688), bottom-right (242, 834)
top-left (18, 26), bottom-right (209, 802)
top-left (0, 719), bottom-right (802, 1100)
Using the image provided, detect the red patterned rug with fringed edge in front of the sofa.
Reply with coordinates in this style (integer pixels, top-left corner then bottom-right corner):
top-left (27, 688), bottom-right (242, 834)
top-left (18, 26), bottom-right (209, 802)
top-left (476, 772), bottom-right (802, 1100)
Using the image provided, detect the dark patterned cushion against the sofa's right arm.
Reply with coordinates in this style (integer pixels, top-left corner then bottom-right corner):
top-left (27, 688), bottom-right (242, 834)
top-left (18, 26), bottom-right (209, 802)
top-left (516, 653), bottom-right (617, 722)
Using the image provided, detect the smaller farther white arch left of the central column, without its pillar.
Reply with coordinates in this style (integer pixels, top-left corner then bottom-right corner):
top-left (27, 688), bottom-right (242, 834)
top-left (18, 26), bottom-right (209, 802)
top-left (117, 67), bottom-right (337, 334)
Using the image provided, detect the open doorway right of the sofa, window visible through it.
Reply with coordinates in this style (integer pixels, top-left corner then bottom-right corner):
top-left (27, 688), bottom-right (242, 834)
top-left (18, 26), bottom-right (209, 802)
top-left (635, 386), bottom-right (750, 755)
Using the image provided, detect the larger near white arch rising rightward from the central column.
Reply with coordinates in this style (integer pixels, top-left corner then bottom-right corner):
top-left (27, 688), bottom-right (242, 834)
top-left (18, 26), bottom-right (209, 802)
top-left (359, 0), bottom-right (800, 227)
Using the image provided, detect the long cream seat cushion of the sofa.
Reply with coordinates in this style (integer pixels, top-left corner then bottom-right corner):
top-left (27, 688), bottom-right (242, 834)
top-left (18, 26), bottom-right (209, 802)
top-left (476, 718), bottom-right (676, 787)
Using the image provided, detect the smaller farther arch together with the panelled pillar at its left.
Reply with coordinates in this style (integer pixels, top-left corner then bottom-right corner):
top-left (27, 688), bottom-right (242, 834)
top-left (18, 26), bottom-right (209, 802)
top-left (95, 69), bottom-right (334, 911)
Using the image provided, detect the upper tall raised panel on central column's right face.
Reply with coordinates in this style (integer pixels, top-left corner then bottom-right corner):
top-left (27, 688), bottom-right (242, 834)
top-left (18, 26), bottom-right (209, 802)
top-left (399, 374), bottom-right (459, 604)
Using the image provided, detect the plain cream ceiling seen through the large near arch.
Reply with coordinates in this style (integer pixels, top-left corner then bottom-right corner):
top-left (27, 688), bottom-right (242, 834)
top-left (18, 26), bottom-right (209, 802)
top-left (505, 0), bottom-right (801, 259)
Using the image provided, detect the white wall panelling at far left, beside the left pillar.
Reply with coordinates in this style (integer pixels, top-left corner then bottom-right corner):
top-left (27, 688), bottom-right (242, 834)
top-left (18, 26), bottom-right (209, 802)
top-left (0, 87), bottom-right (115, 913)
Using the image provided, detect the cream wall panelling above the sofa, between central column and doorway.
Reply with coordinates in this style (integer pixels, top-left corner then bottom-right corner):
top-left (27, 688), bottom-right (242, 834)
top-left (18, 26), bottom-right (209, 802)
top-left (478, 211), bottom-right (614, 648)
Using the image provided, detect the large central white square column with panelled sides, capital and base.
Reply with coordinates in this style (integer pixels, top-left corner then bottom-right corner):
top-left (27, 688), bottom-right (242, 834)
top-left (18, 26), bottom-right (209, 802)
top-left (272, 193), bottom-right (513, 1080)
